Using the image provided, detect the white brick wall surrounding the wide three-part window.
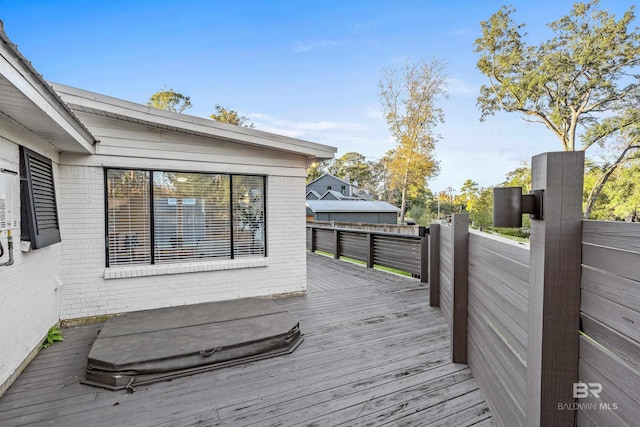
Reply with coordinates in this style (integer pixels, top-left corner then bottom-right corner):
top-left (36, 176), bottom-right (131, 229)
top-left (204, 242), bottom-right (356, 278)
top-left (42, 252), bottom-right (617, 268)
top-left (58, 165), bottom-right (306, 319)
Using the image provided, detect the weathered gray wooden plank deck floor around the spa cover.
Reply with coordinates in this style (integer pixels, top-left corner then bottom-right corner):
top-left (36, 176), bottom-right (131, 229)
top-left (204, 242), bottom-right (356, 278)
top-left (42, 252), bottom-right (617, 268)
top-left (0, 254), bottom-right (494, 426)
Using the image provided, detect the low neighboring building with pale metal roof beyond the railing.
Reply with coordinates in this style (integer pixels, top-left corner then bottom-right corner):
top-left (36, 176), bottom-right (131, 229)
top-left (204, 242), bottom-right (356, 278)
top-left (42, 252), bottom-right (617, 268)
top-left (307, 200), bottom-right (400, 224)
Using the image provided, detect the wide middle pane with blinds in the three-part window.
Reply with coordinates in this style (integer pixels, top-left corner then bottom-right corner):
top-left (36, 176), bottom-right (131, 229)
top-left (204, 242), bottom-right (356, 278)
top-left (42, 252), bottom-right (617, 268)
top-left (153, 172), bottom-right (231, 263)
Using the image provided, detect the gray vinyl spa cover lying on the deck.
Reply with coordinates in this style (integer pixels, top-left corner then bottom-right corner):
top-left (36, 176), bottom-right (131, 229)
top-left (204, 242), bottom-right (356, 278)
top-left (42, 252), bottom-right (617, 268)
top-left (83, 298), bottom-right (302, 391)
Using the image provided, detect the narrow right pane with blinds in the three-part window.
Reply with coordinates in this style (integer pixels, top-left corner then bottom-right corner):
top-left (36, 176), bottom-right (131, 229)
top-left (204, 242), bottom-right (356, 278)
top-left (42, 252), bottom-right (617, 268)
top-left (233, 176), bottom-right (265, 257)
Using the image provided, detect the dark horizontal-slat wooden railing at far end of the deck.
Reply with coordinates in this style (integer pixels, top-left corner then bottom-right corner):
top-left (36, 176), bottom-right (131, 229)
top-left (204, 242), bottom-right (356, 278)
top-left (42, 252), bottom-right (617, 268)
top-left (307, 224), bottom-right (428, 283)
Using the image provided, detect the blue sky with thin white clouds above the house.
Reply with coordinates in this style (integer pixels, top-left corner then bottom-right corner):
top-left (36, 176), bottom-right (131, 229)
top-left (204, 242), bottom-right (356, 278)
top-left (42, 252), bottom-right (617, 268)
top-left (0, 0), bottom-right (638, 191)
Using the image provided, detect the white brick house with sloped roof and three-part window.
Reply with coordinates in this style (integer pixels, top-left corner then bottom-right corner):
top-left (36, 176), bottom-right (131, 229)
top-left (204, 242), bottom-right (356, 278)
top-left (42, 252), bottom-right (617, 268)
top-left (0, 24), bottom-right (336, 395)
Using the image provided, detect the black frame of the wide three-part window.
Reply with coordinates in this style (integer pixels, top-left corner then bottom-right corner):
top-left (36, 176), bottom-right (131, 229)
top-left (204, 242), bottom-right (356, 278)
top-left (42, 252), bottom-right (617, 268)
top-left (103, 167), bottom-right (268, 268)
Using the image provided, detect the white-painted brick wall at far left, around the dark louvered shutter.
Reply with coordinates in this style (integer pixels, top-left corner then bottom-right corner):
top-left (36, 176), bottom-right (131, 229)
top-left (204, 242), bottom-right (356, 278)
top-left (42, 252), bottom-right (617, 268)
top-left (0, 136), bottom-right (61, 392)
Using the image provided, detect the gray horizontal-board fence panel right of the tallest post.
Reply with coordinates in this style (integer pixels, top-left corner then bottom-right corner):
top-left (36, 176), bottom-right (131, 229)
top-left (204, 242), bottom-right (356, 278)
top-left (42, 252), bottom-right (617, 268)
top-left (578, 221), bottom-right (640, 425)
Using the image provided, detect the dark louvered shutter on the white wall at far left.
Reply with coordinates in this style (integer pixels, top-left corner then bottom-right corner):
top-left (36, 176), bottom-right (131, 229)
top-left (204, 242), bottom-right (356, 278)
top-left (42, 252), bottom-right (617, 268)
top-left (20, 147), bottom-right (60, 249)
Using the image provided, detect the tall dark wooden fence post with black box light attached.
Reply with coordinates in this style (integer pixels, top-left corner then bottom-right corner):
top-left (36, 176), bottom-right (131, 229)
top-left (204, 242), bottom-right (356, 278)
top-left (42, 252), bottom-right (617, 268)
top-left (526, 151), bottom-right (584, 426)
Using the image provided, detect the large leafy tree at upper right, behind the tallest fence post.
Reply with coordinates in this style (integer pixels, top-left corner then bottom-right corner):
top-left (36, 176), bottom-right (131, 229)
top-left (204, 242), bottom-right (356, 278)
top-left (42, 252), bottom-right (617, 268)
top-left (475, 0), bottom-right (640, 217)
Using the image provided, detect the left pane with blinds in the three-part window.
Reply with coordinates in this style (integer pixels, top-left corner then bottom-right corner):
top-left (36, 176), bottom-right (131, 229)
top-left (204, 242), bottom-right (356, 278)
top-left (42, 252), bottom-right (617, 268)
top-left (107, 170), bottom-right (151, 266)
